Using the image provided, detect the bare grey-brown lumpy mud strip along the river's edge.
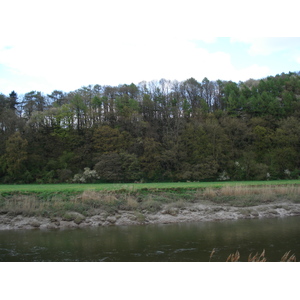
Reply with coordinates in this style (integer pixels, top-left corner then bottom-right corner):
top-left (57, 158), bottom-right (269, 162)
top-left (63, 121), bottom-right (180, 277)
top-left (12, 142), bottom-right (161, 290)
top-left (0, 202), bottom-right (300, 230)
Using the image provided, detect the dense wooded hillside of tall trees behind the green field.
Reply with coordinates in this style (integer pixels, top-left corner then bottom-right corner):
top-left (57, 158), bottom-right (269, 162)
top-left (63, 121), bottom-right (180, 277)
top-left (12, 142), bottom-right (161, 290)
top-left (0, 72), bottom-right (300, 183)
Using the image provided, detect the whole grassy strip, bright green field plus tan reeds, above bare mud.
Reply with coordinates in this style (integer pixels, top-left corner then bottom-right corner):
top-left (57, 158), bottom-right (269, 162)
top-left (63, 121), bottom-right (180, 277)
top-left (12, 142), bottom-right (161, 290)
top-left (0, 181), bottom-right (300, 219)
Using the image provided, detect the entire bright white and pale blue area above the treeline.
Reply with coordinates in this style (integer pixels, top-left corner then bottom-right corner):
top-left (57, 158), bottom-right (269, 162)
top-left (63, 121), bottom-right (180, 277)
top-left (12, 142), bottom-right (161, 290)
top-left (0, 0), bottom-right (300, 95)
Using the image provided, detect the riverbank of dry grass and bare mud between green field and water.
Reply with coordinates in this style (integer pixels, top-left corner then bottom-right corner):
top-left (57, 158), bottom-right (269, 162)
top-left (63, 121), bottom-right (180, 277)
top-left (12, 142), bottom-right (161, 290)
top-left (0, 185), bottom-right (300, 230)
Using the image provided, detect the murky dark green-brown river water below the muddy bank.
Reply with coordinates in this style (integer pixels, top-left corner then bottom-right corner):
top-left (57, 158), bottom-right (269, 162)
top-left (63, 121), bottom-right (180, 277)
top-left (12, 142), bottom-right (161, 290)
top-left (0, 217), bottom-right (300, 262)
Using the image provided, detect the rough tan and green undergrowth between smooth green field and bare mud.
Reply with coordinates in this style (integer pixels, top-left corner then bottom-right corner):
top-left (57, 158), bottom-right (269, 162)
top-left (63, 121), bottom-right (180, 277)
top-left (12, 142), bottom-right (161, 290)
top-left (0, 185), bottom-right (300, 217)
